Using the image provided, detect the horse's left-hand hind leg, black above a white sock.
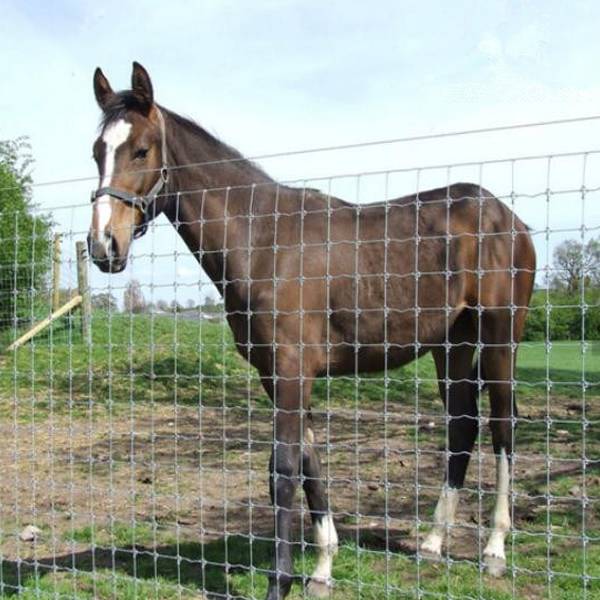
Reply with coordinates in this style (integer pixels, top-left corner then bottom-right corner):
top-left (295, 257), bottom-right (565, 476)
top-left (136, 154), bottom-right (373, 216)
top-left (420, 312), bottom-right (479, 558)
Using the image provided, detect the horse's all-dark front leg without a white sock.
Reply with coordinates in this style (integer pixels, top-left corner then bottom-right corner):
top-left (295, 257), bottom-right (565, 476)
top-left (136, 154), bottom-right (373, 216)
top-left (265, 375), bottom-right (303, 600)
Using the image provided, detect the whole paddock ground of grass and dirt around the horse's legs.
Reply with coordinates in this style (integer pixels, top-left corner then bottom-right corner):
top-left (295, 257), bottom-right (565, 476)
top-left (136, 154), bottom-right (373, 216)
top-left (0, 313), bottom-right (600, 600)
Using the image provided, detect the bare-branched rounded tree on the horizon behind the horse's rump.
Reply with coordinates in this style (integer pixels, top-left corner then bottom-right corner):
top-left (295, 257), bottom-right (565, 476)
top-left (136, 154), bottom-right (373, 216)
top-left (550, 237), bottom-right (600, 294)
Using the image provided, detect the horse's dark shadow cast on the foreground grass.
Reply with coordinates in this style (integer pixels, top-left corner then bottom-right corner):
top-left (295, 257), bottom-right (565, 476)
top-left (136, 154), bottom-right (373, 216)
top-left (0, 526), bottom-right (424, 600)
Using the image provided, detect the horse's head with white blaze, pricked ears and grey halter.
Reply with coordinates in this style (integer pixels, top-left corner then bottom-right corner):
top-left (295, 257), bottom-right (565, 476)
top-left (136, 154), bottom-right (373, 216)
top-left (88, 63), bottom-right (168, 273)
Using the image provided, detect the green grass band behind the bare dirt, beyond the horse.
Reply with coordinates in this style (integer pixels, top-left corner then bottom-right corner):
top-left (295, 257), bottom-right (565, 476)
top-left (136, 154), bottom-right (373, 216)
top-left (0, 312), bottom-right (600, 416)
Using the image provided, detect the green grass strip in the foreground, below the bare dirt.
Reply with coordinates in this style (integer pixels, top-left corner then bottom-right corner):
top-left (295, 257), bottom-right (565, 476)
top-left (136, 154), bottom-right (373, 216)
top-left (2, 536), bottom-right (600, 600)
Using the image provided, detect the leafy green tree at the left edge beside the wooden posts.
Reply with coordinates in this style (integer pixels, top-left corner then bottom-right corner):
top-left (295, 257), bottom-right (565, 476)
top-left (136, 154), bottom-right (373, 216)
top-left (0, 138), bottom-right (51, 328)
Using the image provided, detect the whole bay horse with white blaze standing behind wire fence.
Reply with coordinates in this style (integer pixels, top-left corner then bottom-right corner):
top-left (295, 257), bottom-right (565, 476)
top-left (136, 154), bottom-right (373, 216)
top-left (88, 63), bottom-right (535, 600)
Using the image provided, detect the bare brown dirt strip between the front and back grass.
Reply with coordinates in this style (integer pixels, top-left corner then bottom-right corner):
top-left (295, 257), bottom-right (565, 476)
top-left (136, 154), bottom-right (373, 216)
top-left (0, 398), bottom-right (600, 588)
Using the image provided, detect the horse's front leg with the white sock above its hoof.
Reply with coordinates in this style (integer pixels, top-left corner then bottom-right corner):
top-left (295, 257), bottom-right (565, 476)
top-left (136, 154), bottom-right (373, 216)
top-left (302, 417), bottom-right (338, 598)
